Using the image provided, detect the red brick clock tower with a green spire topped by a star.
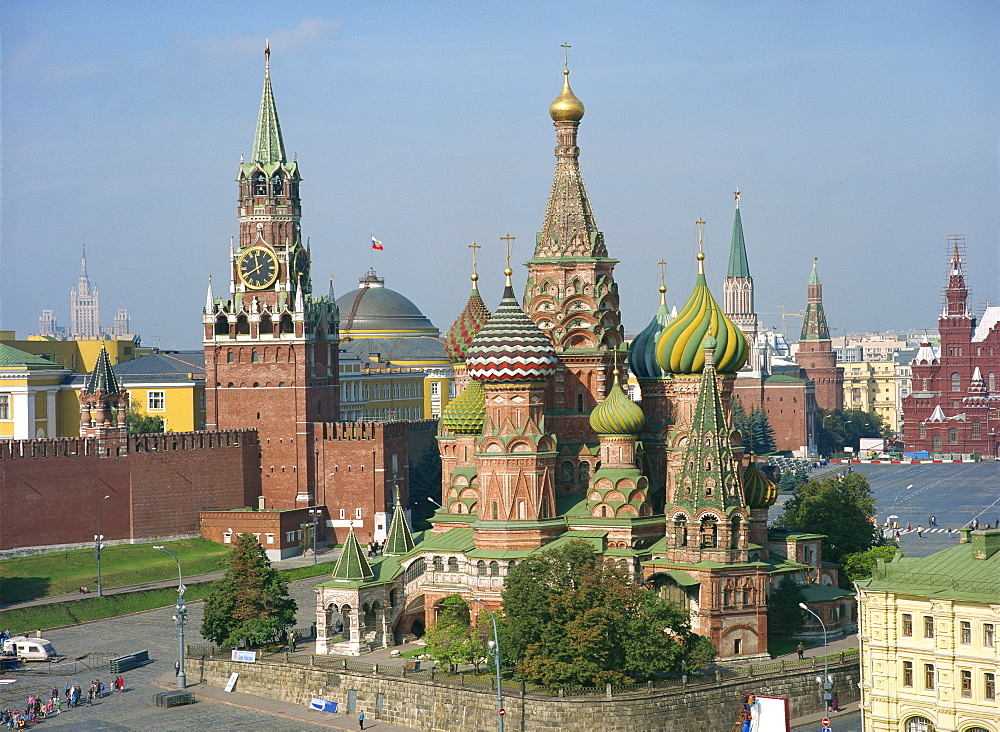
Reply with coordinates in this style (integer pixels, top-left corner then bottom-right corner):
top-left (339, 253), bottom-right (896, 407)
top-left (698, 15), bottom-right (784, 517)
top-left (203, 41), bottom-right (340, 509)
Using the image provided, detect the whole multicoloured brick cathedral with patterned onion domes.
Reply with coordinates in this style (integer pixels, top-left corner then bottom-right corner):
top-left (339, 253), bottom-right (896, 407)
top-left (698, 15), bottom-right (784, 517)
top-left (316, 60), bottom-right (853, 658)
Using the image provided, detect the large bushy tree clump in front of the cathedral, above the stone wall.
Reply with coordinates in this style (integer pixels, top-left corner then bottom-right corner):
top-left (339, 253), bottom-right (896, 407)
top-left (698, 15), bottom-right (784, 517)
top-left (501, 541), bottom-right (716, 686)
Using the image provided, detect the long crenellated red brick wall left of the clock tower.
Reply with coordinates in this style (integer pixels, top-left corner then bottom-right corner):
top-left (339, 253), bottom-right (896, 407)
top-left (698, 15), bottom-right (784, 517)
top-left (0, 430), bottom-right (260, 550)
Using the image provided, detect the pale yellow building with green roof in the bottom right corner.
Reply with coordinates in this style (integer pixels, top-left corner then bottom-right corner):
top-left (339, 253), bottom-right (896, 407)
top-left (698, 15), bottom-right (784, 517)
top-left (858, 529), bottom-right (1000, 732)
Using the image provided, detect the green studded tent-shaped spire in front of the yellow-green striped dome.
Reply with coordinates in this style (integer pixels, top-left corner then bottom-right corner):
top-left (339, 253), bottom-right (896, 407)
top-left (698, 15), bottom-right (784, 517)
top-left (674, 336), bottom-right (743, 516)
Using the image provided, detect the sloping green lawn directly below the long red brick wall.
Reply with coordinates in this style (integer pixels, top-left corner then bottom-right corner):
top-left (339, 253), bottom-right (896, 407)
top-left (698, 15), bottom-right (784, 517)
top-left (0, 539), bottom-right (229, 605)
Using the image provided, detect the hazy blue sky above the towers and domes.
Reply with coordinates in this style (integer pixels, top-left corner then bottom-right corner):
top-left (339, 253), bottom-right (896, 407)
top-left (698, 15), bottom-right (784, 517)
top-left (0, 0), bottom-right (1000, 348)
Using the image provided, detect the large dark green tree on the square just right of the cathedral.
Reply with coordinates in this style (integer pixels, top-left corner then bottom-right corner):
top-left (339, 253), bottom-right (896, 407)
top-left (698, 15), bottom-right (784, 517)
top-left (778, 473), bottom-right (883, 562)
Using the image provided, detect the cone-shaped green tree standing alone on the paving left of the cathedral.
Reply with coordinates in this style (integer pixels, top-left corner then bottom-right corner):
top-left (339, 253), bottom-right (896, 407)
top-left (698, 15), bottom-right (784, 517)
top-left (201, 533), bottom-right (297, 648)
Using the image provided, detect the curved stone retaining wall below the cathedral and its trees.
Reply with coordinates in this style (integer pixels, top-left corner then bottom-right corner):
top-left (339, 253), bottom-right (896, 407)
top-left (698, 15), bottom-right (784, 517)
top-left (187, 658), bottom-right (860, 732)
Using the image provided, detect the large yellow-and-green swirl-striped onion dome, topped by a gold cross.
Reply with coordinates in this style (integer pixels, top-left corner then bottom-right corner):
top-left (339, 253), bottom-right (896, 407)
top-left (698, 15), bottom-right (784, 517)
top-left (656, 267), bottom-right (747, 374)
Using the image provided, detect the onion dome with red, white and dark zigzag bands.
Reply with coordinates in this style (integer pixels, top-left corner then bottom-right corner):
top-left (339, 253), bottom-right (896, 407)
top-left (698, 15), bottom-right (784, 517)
top-left (465, 284), bottom-right (559, 381)
